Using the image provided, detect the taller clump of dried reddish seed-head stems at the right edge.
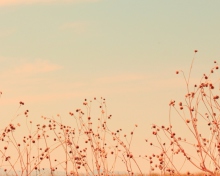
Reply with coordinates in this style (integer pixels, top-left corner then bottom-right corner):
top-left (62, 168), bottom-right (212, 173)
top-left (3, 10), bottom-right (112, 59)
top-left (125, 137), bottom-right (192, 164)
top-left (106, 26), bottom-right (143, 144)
top-left (150, 50), bottom-right (220, 175)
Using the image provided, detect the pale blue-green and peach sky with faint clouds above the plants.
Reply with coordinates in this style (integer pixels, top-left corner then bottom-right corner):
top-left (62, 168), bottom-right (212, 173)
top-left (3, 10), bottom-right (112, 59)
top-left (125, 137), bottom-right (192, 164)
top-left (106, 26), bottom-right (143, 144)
top-left (0, 0), bottom-right (220, 173)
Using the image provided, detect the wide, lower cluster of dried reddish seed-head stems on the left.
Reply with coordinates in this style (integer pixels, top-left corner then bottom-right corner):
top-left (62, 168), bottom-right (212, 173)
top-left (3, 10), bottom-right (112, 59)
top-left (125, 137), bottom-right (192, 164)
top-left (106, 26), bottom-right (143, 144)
top-left (0, 98), bottom-right (141, 176)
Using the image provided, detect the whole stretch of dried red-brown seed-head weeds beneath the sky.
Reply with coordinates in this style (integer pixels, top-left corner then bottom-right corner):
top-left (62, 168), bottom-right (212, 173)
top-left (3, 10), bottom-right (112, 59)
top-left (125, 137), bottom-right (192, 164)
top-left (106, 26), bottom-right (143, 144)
top-left (0, 50), bottom-right (220, 176)
